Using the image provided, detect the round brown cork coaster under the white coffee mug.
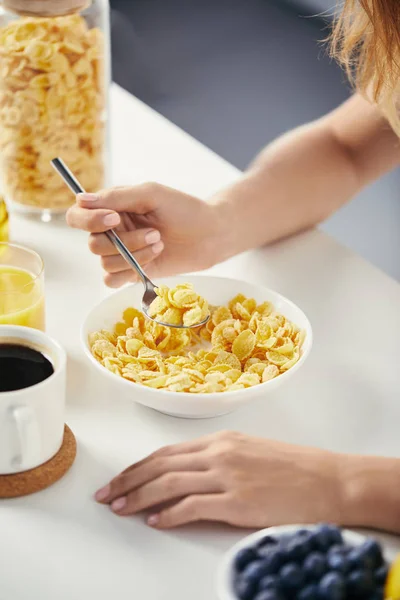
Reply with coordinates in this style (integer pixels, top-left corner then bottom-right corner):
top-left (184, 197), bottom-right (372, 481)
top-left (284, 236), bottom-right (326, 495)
top-left (0, 425), bottom-right (76, 498)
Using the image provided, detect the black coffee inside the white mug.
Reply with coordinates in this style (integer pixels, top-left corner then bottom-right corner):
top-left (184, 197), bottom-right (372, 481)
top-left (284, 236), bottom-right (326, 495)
top-left (0, 342), bottom-right (54, 392)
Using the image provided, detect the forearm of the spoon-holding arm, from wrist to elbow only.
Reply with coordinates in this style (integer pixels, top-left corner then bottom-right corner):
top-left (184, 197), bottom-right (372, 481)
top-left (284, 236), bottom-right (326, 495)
top-left (215, 125), bottom-right (359, 254)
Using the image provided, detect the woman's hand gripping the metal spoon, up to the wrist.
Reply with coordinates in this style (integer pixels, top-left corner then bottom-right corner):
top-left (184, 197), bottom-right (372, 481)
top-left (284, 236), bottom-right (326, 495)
top-left (67, 183), bottom-right (228, 287)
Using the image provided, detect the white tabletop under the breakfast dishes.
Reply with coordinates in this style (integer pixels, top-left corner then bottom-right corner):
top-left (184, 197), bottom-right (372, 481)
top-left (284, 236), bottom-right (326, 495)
top-left (0, 86), bottom-right (400, 600)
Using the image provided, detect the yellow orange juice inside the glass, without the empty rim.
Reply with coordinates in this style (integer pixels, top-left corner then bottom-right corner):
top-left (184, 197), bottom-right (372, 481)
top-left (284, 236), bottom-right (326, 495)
top-left (0, 265), bottom-right (45, 331)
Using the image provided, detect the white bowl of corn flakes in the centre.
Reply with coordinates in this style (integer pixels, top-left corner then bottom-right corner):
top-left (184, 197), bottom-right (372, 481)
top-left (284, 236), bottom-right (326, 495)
top-left (81, 275), bottom-right (312, 418)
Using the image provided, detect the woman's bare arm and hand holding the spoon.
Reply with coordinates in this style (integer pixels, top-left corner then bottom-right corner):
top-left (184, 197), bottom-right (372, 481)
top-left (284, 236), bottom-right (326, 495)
top-left (67, 96), bottom-right (400, 287)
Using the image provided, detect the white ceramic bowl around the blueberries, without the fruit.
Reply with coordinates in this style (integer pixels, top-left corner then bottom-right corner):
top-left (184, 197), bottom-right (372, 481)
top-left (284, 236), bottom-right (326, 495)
top-left (217, 525), bottom-right (380, 600)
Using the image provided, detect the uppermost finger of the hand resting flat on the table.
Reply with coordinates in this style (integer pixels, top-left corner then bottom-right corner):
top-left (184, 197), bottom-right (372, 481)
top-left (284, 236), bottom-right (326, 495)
top-left (96, 453), bottom-right (207, 504)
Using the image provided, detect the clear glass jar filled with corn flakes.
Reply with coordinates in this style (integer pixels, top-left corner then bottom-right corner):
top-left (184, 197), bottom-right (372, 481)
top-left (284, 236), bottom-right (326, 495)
top-left (0, 0), bottom-right (111, 221)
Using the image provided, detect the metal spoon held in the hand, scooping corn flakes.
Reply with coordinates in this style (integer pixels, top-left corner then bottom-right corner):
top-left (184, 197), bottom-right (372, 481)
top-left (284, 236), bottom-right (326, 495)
top-left (51, 158), bottom-right (210, 329)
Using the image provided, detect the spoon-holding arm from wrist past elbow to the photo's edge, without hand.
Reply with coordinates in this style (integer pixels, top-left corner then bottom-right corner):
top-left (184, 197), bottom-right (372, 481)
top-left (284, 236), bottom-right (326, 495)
top-left (211, 95), bottom-right (400, 255)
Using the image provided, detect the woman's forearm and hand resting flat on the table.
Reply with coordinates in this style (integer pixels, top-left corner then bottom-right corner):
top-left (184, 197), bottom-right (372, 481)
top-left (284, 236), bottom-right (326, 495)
top-left (96, 432), bottom-right (400, 533)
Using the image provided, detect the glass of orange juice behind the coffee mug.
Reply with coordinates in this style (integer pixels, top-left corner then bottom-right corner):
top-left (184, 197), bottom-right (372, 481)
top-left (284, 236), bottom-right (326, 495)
top-left (0, 243), bottom-right (45, 331)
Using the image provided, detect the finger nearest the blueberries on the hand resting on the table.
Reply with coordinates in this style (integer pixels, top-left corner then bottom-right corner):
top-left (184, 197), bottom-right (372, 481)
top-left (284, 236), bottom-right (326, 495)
top-left (147, 494), bottom-right (229, 529)
